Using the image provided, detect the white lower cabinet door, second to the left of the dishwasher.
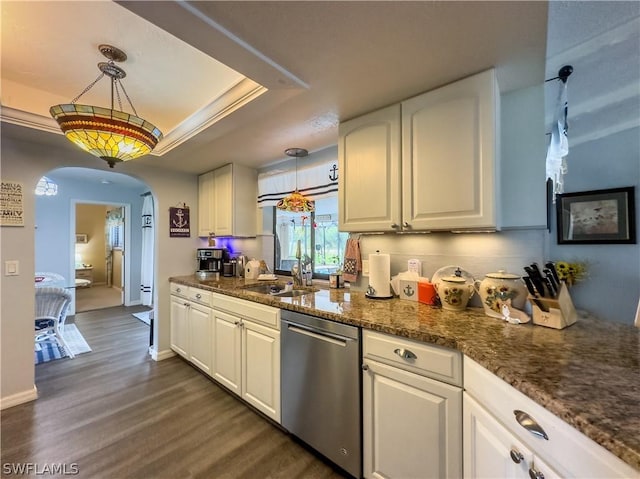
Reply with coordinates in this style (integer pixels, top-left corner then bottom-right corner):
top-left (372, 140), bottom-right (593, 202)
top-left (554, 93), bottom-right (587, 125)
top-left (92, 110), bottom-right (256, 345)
top-left (213, 309), bottom-right (242, 396)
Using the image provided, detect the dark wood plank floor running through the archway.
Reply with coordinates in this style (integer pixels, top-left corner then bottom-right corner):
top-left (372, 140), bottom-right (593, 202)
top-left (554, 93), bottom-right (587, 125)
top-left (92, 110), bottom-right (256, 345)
top-left (0, 306), bottom-right (345, 479)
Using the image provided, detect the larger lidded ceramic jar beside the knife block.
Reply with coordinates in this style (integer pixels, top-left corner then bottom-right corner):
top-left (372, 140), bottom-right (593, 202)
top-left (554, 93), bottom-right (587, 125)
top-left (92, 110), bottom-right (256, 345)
top-left (475, 270), bottom-right (527, 318)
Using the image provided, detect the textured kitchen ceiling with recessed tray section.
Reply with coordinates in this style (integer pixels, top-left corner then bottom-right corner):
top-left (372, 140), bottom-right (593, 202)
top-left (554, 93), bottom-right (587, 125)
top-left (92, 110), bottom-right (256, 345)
top-left (0, 0), bottom-right (640, 185)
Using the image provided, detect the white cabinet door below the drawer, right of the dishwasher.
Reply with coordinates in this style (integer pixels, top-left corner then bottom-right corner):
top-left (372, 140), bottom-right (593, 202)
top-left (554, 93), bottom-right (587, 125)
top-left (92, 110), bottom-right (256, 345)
top-left (363, 359), bottom-right (462, 479)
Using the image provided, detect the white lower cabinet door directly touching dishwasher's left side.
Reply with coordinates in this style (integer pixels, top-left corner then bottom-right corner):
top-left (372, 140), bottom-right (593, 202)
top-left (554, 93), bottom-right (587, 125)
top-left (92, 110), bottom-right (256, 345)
top-left (242, 320), bottom-right (280, 423)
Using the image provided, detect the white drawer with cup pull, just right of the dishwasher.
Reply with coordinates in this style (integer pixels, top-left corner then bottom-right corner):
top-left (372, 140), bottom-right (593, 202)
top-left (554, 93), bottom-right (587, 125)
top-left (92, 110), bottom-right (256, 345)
top-left (363, 330), bottom-right (462, 386)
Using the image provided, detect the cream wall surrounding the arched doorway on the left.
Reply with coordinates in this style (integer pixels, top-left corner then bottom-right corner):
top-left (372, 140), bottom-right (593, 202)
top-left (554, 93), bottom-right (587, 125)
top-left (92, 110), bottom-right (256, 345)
top-left (0, 131), bottom-right (198, 408)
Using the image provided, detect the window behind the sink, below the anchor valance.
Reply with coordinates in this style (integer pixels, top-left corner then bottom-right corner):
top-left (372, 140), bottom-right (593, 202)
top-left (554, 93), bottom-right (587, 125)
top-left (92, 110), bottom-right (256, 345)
top-left (274, 196), bottom-right (349, 278)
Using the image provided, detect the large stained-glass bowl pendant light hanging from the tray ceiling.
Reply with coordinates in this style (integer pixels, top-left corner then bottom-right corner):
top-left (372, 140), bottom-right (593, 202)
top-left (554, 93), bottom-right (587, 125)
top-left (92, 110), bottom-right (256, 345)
top-left (49, 45), bottom-right (162, 168)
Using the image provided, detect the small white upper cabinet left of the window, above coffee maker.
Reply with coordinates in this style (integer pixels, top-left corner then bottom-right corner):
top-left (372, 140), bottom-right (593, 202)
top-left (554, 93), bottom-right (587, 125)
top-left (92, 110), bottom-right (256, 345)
top-left (198, 163), bottom-right (258, 237)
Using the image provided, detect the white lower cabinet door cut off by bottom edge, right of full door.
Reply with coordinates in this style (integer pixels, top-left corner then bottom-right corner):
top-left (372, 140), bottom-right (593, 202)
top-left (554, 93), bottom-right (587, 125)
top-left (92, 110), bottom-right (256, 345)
top-left (463, 394), bottom-right (528, 479)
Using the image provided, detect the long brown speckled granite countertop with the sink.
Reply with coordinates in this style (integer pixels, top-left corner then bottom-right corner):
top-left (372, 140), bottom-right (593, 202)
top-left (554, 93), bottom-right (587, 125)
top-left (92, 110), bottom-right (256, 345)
top-left (170, 276), bottom-right (640, 470)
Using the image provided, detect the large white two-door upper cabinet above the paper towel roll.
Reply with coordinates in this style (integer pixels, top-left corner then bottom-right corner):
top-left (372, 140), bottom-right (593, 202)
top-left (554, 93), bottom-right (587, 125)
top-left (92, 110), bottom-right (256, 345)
top-left (338, 70), bottom-right (500, 232)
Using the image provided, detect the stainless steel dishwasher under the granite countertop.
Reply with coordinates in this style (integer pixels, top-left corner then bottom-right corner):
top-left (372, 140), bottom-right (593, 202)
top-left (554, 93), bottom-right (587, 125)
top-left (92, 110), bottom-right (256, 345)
top-left (280, 310), bottom-right (362, 478)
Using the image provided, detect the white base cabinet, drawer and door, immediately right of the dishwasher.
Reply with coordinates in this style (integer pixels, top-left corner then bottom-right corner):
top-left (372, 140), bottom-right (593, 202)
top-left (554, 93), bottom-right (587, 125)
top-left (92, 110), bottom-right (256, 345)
top-left (363, 331), bottom-right (462, 478)
